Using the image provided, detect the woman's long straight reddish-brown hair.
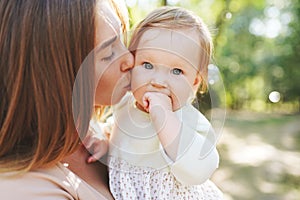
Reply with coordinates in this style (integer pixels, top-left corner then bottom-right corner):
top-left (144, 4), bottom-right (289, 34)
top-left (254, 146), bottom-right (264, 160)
top-left (0, 0), bottom-right (96, 171)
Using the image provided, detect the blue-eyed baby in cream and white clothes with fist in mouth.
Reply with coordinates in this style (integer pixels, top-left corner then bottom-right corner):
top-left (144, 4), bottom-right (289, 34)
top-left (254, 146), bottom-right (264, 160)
top-left (103, 7), bottom-right (222, 200)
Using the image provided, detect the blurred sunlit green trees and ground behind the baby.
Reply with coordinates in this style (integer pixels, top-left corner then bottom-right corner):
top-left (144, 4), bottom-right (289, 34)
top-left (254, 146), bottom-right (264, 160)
top-left (126, 0), bottom-right (300, 200)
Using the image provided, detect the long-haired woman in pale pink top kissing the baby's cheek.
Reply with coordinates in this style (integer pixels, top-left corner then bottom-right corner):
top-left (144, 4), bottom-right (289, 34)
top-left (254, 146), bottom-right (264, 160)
top-left (0, 0), bottom-right (133, 200)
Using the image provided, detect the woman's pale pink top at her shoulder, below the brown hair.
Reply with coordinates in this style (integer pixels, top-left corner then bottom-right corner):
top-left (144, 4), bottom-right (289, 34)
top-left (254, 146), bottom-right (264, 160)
top-left (0, 163), bottom-right (105, 200)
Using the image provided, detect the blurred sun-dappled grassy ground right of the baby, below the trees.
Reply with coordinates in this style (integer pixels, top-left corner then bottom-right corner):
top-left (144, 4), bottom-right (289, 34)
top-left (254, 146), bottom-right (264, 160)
top-left (212, 112), bottom-right (300, 200)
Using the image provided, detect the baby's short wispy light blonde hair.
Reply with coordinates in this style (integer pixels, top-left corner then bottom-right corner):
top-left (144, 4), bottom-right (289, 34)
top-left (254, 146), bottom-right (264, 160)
top-left (129, 6), bottom-right (213, 92)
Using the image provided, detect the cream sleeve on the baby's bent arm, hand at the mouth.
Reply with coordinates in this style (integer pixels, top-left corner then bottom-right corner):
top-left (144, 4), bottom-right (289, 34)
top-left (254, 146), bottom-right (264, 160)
top-left (170, 105), bottom-right (219, 185)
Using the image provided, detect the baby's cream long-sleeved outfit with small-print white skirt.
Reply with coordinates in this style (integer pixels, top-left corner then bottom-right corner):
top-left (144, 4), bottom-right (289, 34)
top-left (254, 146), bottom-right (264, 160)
top-left (107, 93), bottom-right (222, 200)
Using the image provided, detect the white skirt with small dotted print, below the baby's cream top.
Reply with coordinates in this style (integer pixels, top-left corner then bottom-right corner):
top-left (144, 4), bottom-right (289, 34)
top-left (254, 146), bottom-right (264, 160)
top-left (109, 157), bottom-right (223, 200)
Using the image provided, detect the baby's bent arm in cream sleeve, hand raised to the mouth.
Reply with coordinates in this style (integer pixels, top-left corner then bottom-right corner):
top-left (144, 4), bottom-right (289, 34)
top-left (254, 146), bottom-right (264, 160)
top-left (144, 92), bottom-right (219, 185)
